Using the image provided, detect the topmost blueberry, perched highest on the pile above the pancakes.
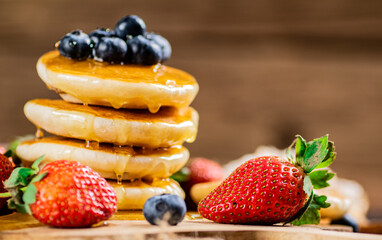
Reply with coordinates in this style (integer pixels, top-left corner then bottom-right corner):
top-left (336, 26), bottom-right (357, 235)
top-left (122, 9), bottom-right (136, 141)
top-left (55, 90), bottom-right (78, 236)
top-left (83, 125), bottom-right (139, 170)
top-left (115, 15), bottom-right (146, 40)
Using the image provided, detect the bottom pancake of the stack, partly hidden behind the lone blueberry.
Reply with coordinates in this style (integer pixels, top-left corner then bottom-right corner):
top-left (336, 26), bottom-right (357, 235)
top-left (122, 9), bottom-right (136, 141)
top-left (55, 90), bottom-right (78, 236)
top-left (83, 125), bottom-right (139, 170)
top-left (108, 178), bottom-right (185, 210)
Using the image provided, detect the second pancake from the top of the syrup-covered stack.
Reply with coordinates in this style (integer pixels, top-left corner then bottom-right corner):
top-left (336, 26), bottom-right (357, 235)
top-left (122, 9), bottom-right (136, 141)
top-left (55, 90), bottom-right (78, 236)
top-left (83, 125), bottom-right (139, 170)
top-left (24, 99), bottom-right (199, 148)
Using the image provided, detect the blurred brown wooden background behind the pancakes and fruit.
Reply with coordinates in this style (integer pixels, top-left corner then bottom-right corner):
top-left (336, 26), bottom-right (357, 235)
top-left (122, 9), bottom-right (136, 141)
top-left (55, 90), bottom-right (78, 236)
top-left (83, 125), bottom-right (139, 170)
top-left (0, 0), bottom-right (382, 217)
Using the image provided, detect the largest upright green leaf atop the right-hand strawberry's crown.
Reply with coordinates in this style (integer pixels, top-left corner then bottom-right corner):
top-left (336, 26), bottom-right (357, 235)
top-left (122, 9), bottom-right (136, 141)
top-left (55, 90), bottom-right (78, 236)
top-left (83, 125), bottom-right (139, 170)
top-left (301, 135), bottom-right (328, 173)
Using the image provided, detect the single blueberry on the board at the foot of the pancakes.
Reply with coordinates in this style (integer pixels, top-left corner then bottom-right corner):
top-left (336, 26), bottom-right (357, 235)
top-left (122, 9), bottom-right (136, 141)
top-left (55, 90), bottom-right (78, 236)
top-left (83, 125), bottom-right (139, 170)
top-left (143, 194), bottom-right (187, 225)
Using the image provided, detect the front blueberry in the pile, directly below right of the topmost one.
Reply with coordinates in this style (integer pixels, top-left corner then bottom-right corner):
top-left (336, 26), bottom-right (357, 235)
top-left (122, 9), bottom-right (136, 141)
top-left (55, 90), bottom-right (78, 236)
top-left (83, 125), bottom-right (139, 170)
top-left (126, 35), bottom-right (162, 65)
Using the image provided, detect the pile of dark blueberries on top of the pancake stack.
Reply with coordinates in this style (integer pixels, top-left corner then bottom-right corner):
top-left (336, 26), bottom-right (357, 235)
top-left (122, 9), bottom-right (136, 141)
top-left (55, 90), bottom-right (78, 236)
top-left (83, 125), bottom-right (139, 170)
top-left (58, 15), bottom-right (171, 65)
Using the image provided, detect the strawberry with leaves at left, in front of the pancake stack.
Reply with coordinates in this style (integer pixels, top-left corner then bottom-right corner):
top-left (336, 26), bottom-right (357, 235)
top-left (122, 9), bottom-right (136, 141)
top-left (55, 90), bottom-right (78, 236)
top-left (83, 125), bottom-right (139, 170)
top-left (0, 157), bottom-right (117, 228)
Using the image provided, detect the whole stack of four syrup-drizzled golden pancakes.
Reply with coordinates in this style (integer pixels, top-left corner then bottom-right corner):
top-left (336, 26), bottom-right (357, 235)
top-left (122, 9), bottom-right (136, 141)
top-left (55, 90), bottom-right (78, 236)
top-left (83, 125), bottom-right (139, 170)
top-left (16, 51), bottom-right (199, 210)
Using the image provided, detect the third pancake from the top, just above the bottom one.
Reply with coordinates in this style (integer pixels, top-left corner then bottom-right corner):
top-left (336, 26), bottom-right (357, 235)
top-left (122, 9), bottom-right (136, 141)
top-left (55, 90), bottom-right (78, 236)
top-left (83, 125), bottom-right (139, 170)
top-left (16, 137), bottom-right (189, 180)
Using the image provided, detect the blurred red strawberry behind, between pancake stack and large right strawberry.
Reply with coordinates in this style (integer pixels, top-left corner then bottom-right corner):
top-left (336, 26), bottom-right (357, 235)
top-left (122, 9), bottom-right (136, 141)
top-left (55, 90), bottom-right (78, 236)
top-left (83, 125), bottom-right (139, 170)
top-left (188, 158), bottom-right (224, 185)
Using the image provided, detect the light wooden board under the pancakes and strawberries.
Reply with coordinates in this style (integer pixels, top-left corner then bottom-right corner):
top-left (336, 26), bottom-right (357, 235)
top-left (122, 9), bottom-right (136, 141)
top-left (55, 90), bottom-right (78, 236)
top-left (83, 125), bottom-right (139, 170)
top-left (0, 212), bottom-right (382, 240)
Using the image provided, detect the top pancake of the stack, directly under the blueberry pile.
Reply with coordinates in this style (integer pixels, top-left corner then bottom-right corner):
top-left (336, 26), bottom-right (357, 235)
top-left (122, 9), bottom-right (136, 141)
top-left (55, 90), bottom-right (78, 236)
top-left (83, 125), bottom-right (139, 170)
top-left (37, 51), bottom-right (199, 113)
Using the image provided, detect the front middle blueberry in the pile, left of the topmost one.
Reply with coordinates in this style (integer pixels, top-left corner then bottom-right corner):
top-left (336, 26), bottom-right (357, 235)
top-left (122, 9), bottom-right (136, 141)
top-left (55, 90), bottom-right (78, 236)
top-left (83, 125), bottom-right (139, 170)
top-left (94, 37), bottom-right (127, 63)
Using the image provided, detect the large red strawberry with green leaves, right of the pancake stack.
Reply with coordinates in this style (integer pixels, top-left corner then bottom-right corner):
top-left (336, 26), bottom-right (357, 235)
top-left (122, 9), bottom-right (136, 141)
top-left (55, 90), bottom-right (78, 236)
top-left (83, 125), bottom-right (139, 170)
top-left (198, 136), bottom-right (335, 225)
